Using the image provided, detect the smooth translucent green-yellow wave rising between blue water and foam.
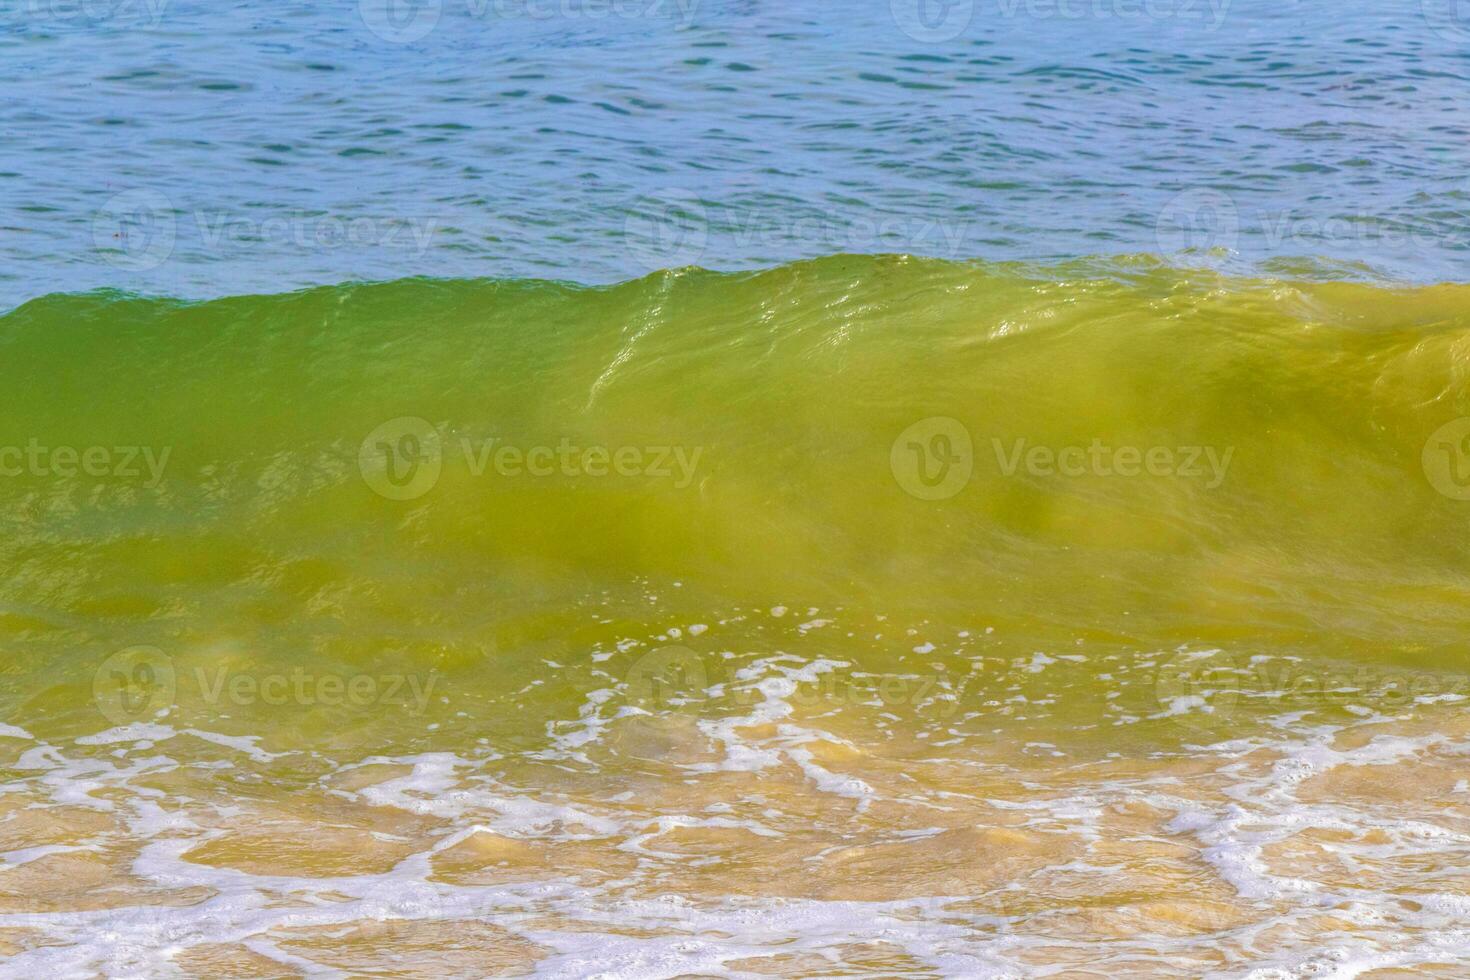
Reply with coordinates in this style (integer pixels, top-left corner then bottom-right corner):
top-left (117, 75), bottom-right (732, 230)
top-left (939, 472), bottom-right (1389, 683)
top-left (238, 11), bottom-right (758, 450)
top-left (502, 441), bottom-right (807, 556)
top-left (0, 256), bottom-right (1470, 740)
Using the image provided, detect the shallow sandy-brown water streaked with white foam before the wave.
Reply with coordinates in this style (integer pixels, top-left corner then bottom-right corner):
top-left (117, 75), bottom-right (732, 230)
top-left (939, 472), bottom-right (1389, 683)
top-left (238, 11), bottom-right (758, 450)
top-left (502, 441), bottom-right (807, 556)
top-left (0, 640), bottom-right (1470, 979)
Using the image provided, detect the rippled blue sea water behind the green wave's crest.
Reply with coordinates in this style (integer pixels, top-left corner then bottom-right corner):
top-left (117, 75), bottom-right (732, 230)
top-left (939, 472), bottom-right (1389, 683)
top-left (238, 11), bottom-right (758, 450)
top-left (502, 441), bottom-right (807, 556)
top-left (0, 0), bottom-right (1470, 306)
